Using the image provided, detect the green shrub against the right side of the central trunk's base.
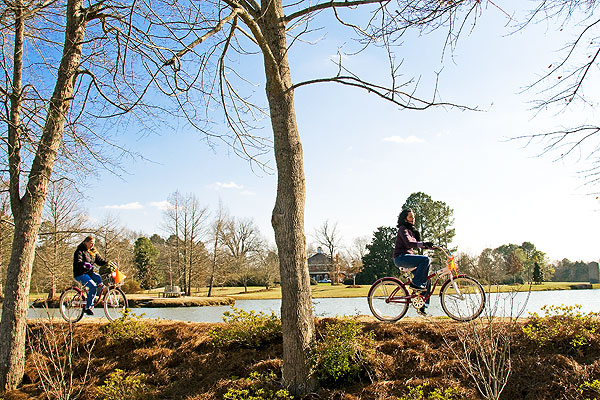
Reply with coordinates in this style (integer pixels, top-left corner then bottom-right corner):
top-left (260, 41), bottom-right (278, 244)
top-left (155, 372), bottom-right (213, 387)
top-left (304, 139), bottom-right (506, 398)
top-left (311, 318), bottom-right (375, 385)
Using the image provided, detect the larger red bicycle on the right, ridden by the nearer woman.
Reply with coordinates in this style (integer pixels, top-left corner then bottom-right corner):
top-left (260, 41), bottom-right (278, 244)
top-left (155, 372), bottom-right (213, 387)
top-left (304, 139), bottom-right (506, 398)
top-left (367, 246), bottom-right (485, 322)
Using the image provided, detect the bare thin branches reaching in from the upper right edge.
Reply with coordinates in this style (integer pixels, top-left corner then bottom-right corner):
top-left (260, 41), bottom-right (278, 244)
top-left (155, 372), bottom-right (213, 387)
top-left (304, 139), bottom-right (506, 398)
top-left (515, 0), bottom-right (600, 186)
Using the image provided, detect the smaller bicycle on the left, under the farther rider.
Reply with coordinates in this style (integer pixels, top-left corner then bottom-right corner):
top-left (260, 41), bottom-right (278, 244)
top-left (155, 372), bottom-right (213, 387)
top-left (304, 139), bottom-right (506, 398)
top-left (59, 264), bottom-right (127, 323)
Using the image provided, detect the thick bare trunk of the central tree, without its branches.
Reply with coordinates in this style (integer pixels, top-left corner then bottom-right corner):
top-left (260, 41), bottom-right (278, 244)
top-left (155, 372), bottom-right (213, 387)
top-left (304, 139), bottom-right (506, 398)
top-left (257, 1), bottom-right (315, 395)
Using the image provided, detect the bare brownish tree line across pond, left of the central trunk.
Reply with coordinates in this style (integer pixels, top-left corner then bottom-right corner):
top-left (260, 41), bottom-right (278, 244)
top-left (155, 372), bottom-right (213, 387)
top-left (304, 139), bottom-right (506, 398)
top-left (5, 181), bottom-right (279, 298)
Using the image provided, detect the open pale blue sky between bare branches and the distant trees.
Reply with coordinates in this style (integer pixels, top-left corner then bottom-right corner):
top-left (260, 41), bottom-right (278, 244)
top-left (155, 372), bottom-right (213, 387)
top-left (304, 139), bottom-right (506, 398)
top-left (82, 2), bottom-right (600, 261)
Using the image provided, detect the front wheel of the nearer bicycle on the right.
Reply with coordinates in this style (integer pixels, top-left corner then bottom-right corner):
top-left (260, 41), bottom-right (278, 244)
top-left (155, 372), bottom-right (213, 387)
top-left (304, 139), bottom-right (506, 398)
top-left (440, 275), bottom-right (485, 321)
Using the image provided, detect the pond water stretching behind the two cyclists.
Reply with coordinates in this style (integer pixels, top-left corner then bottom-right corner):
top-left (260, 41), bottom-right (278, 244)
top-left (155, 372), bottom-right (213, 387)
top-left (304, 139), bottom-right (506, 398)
top-left (27, 289), bottom-right (600, 322)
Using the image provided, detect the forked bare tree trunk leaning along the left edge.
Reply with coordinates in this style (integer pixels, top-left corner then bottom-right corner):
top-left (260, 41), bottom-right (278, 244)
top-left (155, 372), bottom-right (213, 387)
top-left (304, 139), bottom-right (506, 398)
top-left (0, 0), bottom-right (87, 389)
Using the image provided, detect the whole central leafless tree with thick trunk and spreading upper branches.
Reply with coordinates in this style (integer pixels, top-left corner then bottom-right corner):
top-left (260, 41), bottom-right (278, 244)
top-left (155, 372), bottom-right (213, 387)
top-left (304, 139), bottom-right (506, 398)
top-left (151, 0), bottom-right (481, 395)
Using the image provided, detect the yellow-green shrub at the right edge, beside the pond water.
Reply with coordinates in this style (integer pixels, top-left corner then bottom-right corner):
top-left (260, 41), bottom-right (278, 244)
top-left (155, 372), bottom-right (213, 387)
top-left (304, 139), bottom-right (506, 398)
top-left (523, 304), bottom-right (600, 348)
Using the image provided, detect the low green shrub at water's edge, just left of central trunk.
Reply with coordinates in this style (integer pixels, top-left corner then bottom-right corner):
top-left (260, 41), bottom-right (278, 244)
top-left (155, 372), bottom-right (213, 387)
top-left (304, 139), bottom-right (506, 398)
top-left (208, 307), bottom-right (281, 348)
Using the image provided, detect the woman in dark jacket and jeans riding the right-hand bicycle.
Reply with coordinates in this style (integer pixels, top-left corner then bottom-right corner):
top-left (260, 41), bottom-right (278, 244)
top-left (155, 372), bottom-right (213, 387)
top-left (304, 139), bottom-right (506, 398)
top-left (394, 208), bottom-right (433, 314)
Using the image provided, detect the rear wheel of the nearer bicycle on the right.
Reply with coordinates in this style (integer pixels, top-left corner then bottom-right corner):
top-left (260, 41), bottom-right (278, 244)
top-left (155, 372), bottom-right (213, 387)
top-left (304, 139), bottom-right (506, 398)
top-left (367, 278), bottom-right (410, 322)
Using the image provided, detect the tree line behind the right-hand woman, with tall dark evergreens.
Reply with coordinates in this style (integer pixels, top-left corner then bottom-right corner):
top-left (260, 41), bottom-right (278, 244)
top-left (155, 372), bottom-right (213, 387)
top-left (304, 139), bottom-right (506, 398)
top-left (356, 192), bottom-right (588, 284)
